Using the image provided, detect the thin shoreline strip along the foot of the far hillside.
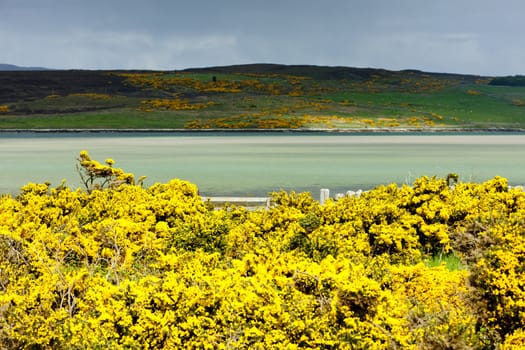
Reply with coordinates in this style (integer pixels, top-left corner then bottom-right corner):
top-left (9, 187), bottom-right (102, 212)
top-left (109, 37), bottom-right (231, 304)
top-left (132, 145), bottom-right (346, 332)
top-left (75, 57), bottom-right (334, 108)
top-left (0, 128), bottom-right (525, 134)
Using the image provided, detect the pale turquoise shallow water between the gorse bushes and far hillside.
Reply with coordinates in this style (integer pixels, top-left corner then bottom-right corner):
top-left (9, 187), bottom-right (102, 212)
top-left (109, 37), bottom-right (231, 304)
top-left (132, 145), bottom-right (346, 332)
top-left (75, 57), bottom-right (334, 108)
top-left (0, 133), bottom-right (525, 196)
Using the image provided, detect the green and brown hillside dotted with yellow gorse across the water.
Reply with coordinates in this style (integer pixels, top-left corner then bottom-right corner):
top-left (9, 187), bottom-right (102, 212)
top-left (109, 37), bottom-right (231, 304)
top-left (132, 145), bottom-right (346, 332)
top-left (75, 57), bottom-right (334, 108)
top-left (0, 64), bottom-right (525, 129)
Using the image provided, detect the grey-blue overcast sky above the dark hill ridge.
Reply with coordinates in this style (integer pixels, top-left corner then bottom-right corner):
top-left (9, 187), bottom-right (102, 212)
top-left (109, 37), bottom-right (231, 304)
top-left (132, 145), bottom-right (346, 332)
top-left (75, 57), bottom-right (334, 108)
top-left (0, 0), bottom-right (525, 75)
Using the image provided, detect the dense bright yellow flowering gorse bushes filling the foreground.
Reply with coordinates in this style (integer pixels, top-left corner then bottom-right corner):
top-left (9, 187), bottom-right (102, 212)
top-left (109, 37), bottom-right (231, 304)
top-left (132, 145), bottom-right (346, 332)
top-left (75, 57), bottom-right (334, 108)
top-left (0, 151), bottom-right (525, 349)
